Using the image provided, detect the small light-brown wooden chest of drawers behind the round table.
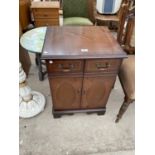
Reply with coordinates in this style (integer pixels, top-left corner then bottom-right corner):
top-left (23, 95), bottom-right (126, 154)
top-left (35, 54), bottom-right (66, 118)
top-left (31, 1), bottom-right (60, 27)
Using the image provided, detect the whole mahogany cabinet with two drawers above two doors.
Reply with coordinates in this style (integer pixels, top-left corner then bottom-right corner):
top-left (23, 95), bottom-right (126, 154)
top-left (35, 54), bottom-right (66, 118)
top-left (41, 26), bottom-right (126, 117)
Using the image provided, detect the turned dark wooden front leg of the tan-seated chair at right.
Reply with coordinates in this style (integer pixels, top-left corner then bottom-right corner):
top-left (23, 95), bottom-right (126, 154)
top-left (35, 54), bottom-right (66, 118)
top-left (115, 97), bottom-right (134, 123)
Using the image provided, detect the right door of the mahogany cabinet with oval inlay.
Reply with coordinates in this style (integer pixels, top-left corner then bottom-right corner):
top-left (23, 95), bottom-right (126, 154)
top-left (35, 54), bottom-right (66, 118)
top-left (81, 76), bottom-right (115, 109)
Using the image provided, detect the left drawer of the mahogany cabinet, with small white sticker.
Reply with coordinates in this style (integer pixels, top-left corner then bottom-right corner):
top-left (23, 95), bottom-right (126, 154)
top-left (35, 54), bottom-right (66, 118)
top-left (46, 60), bottom-right (84, 73)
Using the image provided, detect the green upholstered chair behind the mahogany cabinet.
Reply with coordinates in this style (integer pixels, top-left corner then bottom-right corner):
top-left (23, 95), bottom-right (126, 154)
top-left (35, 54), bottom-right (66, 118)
top-left (62, 0), bottom-right (94, 26)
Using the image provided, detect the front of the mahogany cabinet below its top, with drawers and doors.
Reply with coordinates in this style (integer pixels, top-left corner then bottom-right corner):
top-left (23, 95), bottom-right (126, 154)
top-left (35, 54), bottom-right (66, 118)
top-left (46, 59), bottom-right (121, 117)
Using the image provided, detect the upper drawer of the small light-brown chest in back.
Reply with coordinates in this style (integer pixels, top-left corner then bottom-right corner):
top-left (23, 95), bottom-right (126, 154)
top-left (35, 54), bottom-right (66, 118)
top-left (32, 8), bottom-right (59, 18)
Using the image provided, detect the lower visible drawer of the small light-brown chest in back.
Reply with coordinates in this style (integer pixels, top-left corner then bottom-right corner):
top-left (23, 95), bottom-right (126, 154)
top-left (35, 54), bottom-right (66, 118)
top-left (35, 19), bottom-right (59, 26)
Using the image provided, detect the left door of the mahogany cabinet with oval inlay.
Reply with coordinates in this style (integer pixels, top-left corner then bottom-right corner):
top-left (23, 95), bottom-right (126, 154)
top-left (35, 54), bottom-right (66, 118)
top-left (49, 77), bottom-right (82, 110)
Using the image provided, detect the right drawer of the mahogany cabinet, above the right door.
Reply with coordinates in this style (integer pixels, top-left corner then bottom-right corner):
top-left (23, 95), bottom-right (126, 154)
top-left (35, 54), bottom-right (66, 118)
top-left (85, 59), bottom-right (121, 72)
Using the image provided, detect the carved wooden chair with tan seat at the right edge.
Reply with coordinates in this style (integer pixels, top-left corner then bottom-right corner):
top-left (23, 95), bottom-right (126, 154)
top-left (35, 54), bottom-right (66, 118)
top-left (116, 0), bottom-right (135, 122)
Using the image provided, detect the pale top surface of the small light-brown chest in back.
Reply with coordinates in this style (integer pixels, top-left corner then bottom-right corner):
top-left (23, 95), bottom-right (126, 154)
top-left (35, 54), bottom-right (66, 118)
top-left (31, 1), bottom-right (60, 8)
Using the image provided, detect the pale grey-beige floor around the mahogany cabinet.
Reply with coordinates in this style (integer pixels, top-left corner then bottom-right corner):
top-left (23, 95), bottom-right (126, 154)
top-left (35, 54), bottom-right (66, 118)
top-left (19, 55), bottom-right (135, 155)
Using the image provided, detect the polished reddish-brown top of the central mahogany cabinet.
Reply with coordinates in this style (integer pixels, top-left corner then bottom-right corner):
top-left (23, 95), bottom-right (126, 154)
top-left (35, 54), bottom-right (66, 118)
top-left (41, 26), bottom-right (127, 59)
